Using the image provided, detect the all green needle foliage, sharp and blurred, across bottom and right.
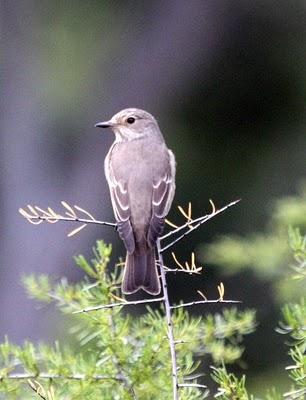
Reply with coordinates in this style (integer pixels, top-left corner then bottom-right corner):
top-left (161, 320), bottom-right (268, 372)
top-left (0, 194), bottom-right (306, 400)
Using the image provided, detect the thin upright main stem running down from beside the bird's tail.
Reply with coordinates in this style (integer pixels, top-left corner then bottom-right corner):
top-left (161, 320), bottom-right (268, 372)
top-left (157, 239), bottom-right (179, 400)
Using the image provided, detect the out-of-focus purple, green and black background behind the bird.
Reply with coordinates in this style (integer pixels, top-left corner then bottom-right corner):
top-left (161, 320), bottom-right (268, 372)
top-left (0, 0), bottom-right (306, 393)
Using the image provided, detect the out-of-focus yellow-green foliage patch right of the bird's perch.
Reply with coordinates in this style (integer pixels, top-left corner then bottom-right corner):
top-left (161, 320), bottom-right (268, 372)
top-left (202, 184), bottom-right (306, 303)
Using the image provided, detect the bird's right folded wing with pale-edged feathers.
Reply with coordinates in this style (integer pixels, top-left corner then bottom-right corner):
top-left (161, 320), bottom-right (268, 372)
top-left (147, 150), bottom-right (175, 247)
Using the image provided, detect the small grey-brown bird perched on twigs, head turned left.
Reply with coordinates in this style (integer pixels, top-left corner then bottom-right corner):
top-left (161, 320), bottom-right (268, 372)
top-left (95, 108), bottom-right (175, 295)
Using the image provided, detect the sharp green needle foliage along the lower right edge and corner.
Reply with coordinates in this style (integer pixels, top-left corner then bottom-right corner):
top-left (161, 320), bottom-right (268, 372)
top-left (208, 228), bottom-right (306, 400)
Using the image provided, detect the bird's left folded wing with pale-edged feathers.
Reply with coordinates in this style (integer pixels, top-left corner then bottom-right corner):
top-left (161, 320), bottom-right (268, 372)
top-left (106, 158), bottom-right (135, 254)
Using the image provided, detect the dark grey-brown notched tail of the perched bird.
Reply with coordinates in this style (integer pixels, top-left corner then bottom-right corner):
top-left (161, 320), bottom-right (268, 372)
top-left (122, 248), bottom-right (160, 295)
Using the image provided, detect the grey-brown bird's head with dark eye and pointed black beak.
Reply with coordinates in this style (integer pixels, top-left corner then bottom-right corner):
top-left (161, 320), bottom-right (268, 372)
top-left (95, 108), bottom-right (161, 142)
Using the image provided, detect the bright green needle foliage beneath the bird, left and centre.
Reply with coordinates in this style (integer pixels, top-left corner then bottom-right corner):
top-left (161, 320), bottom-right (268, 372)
top-left (0, 241), bottom-right (255, 400)
